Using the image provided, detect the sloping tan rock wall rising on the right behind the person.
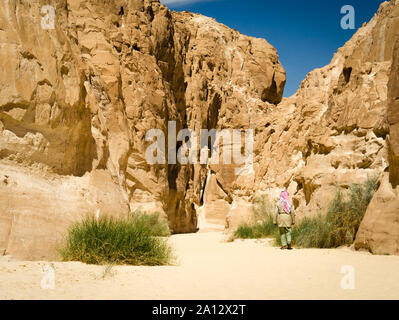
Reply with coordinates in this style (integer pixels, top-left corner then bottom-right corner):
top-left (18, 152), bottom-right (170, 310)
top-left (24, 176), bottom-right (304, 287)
top-left (201, 1), bottom-right (399, 254)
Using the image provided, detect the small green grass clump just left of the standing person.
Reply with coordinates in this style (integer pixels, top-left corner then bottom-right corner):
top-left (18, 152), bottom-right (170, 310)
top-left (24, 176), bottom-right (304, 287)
top-left (234, 198), bottom-right (277, 239)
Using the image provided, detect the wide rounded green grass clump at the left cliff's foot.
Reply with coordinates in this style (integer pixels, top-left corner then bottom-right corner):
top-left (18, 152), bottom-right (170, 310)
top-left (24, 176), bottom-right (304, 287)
top-left (60, 212), bottom-right (172, 266)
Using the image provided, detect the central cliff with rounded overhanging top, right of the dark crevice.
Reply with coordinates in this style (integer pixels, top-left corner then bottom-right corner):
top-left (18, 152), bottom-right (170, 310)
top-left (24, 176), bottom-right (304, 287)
top-left (173, 13), bottom-right (285, 229)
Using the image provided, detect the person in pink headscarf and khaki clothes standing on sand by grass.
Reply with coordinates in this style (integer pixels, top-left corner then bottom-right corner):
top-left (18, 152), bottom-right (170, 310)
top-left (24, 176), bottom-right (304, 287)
top-left (273, 190), bottom-right (295, 250)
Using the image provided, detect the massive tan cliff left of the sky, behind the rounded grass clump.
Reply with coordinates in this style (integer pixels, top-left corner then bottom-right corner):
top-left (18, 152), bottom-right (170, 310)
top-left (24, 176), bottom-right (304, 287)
top-left (0, 0), bottom-right (285, 259)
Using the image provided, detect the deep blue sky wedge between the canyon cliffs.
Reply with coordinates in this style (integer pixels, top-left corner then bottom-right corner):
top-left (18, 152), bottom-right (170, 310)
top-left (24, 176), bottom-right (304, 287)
top-left (161, 0), bottom-right (383, 97)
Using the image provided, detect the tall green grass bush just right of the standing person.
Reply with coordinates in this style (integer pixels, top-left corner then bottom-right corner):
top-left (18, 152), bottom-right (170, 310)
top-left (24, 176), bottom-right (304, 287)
top-left (275, 177), bottom-right (377, 248)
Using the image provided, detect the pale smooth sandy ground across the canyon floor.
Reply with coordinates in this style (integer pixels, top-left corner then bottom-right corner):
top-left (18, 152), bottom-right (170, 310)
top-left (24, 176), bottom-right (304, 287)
top-left (0, 232), bottom-right (399, 300)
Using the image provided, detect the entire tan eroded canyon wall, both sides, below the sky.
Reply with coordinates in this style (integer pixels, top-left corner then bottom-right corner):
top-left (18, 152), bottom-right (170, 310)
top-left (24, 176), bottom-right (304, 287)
top-left (0, 0), bottom-right (399, 259)
